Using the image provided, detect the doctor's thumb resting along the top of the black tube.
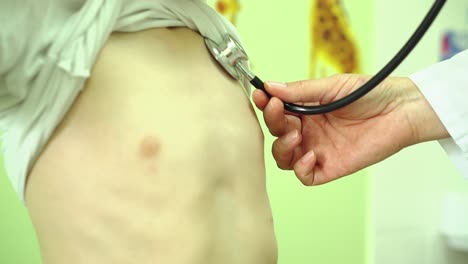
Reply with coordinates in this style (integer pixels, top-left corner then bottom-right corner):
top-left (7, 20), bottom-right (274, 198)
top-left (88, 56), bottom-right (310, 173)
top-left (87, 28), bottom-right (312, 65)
top-left (265, 80), bottom-right (327, 103)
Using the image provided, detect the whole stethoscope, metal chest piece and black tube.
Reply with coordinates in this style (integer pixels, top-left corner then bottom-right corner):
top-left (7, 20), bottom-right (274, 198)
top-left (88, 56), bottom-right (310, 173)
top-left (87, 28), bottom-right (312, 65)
top-left (205, 0), bottom-right (446, 115)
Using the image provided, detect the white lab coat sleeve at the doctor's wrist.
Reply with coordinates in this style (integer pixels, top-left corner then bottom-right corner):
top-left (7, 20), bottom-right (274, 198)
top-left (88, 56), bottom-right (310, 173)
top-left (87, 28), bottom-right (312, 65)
top-left (410, 50), bottom-right (468, 179)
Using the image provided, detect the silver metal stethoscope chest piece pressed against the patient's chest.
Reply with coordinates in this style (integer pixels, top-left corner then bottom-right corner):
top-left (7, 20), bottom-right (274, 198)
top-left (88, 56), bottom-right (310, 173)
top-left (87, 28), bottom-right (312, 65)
top-left (205, 34), bottom-right (249, 80)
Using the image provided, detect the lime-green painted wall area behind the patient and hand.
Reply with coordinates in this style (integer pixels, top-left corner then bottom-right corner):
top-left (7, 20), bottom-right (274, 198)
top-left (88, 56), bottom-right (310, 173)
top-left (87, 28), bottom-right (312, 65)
top-left (0, 0), bottom-right (372, 264)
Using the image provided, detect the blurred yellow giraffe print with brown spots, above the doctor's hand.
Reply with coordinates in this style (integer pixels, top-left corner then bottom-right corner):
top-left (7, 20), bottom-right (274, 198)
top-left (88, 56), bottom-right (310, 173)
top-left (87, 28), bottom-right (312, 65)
top-left (310, 0), bottom-right (359, 78)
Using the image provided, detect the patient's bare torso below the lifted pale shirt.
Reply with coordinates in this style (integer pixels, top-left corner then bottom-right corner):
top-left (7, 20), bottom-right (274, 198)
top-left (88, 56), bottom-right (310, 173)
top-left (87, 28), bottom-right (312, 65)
top-left (26, 28), bottom-right (277, 264)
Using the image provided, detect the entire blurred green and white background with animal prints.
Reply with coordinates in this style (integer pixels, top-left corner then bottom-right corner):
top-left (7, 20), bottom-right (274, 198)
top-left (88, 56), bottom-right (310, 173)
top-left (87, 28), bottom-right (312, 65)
top-left (0, 0), bottom-right (468, 264)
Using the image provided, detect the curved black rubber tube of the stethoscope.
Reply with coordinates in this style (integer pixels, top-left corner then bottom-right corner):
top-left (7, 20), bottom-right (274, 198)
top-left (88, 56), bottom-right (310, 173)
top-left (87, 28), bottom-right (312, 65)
top-left (250, 0), bottom-right (446, 115)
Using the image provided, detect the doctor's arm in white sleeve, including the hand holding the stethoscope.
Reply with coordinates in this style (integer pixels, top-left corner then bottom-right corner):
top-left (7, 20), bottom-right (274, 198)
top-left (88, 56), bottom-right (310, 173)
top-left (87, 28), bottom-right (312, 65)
top-left (254, 52), bottom-right (468, 185)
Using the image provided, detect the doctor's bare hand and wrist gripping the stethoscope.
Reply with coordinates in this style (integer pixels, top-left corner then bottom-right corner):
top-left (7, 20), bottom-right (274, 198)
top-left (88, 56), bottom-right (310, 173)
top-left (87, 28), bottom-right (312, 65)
top-left (253, 74), bottom-right (449, 185)
